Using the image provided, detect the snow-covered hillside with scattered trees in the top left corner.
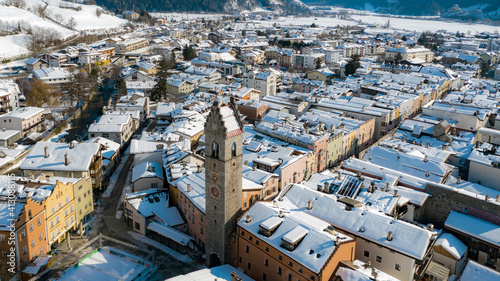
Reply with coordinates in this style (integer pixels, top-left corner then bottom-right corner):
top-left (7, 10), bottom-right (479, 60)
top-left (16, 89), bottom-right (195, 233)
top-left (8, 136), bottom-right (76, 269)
top-left (0, 0), bottom-right (127, 59)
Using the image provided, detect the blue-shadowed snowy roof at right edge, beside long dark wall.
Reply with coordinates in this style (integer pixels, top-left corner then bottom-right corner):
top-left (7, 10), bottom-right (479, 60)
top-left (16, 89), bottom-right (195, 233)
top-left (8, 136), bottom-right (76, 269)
top-left (444, 211), bottom-right (500, 247)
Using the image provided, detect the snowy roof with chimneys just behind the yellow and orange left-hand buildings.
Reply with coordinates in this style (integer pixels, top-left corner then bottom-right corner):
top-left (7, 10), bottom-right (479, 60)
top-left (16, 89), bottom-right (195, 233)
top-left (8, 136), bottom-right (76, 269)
top-left (21, 142), bottom-right (101, 171)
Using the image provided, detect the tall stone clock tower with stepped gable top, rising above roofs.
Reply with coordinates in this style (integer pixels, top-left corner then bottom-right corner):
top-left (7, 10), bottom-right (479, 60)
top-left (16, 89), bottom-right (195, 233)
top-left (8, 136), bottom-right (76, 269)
top-left (205, 100), bottom-right (244, 267)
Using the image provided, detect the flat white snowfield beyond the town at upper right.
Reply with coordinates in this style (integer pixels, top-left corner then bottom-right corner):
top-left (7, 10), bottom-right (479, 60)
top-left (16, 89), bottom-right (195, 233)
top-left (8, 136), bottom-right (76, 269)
top-left (351, 15), bottom-right (500, 34)
